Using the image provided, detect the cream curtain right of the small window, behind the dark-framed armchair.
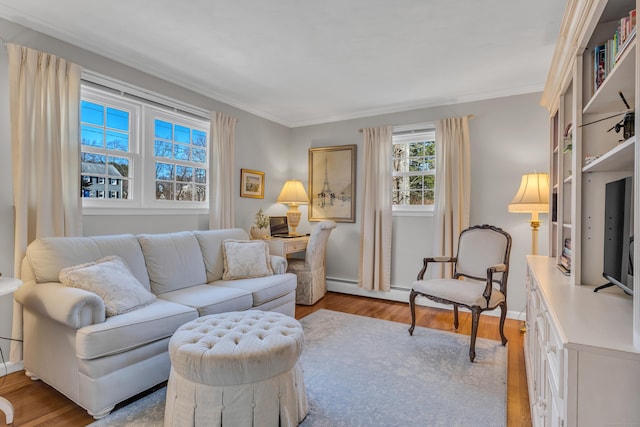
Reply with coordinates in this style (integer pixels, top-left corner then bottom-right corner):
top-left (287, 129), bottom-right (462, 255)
top-left (433, 117), bottom-right (471, 277)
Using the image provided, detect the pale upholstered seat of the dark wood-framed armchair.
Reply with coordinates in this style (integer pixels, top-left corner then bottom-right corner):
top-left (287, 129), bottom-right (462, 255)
top-left (413, 279), bottom-right (504, 308)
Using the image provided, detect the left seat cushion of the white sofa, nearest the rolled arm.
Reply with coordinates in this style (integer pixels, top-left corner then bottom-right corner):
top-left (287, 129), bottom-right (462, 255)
top-left (76, 298), bottom-right (198, 359)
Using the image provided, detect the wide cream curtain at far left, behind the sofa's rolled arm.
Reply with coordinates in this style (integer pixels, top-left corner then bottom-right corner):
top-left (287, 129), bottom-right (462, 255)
top-left (7, 43), bottom-right (82, 361)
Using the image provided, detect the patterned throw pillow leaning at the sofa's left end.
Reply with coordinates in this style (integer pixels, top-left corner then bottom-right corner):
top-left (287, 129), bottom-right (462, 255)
top-left (60, 256), bottom-right (156, 317)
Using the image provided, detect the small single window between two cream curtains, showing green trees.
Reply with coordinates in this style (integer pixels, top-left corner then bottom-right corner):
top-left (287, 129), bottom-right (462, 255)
top-left (392, 125), bottom-right (436, 212)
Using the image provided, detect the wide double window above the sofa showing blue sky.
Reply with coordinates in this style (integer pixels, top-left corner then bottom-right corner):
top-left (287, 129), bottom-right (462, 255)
top-left (80, 83), bottom-right (209, 209)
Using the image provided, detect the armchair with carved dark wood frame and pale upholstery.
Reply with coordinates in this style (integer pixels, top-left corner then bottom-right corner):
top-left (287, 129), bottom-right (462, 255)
top-left (409, 224), bottom-right (511, 362)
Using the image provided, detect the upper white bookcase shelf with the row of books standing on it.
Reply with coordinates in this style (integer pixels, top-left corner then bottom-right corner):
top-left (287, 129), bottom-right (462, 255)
top-left (583, 33), bottom-right (636, 114)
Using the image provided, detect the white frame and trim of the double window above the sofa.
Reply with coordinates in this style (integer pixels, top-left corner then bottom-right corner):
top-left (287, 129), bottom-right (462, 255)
top-left (79, 78), bottom-right (211, 215)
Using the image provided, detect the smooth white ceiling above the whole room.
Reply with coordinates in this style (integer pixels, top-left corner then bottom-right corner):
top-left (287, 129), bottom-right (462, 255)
top-left (0, 0), bottom-right (566, 127)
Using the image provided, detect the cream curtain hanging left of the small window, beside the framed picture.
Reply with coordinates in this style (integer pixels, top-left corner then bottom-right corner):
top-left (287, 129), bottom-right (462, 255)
top-left (358, 126), bottom-right (393, 291)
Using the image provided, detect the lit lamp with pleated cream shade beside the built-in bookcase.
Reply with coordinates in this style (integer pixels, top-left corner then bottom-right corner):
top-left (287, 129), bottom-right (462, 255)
top-left (508, 173), bottom-right (549, 255)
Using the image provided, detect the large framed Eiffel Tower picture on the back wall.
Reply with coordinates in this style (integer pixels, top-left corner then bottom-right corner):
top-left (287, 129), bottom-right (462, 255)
top-left (309, 145), bottom-right (356, 222)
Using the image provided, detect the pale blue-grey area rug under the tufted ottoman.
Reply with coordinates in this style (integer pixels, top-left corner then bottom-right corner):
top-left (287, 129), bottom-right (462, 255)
top-left (86, 309), bottom-right (507, 427)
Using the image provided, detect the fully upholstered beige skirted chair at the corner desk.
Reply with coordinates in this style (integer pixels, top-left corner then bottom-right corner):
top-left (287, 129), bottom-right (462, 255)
top-left (287, 221), bottom-right (336, 305)
